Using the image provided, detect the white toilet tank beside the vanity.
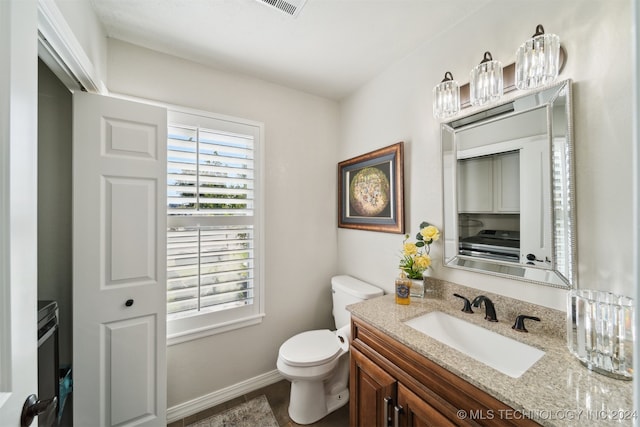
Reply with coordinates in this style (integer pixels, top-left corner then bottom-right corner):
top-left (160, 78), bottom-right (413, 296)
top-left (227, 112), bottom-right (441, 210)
top-left (331, 275), bottom-right (384, 329)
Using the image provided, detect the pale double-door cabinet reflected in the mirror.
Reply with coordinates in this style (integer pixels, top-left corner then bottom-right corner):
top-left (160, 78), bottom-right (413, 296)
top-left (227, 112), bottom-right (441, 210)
top-left (458, 151), bottom-right (520, 213)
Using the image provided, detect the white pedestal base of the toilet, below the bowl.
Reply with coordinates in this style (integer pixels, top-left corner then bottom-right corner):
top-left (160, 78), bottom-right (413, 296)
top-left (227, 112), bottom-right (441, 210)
top-left (289, 380), bottom-right (349, 424)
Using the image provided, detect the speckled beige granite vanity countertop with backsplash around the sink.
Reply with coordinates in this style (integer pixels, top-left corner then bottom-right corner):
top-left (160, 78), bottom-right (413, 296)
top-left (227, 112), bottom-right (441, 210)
top-left (347, 281), bottom-right (637, 426)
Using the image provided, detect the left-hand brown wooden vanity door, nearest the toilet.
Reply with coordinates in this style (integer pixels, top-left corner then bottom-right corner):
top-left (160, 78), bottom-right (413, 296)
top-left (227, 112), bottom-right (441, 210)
top-left (349, 347), bottom-right (396, 427)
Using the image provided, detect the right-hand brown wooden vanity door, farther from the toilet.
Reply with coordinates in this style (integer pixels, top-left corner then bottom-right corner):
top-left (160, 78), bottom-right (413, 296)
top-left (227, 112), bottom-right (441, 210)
top-left (393, 384), bottom-right (462, 427)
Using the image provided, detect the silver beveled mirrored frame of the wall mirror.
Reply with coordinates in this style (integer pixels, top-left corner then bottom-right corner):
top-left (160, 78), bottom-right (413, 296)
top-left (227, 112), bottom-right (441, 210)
top-left (440, 80), bottom-right (578, 289)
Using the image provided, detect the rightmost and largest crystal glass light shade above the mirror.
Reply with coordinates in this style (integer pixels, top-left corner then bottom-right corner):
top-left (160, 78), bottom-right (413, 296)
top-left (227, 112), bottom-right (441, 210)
top-left (516, 25), bottom-right (560, 89)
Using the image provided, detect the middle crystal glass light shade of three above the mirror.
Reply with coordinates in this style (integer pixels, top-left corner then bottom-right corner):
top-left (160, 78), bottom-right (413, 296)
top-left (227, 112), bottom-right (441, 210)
top-left (469, 52), bottom-right (504, 105)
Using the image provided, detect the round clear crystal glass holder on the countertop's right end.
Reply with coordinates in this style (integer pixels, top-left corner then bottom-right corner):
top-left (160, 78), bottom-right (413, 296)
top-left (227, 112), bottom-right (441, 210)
top-left (567, 289), bottom-right (635, 380)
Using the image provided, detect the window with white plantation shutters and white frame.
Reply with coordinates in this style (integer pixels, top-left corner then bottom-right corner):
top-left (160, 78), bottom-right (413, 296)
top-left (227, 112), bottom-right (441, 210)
top-left (167, 111), bottom-right (264, 344)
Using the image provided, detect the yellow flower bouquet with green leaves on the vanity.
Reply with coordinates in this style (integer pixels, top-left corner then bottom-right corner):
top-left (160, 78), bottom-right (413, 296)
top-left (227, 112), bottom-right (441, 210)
top-left (399, 222), bottom-right (440, 279)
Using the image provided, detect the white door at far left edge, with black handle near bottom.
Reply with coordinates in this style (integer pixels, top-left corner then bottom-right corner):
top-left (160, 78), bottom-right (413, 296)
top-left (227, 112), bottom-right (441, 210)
top-left (0, 0), bottom-right (38, 425)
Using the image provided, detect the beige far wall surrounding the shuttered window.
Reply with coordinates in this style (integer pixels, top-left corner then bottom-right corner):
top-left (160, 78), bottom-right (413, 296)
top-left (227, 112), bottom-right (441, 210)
top-left (107, 40), bottom-right (338, 407)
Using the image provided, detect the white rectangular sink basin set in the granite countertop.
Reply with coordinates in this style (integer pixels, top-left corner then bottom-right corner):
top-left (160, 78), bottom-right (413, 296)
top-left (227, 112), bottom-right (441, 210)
top-left (404, 311), bottom-right (544, 378)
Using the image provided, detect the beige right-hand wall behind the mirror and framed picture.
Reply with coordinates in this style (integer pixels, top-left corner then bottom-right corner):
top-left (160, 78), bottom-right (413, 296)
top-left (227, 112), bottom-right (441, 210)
top-left (338, 0), bottom-right (634, 310)
